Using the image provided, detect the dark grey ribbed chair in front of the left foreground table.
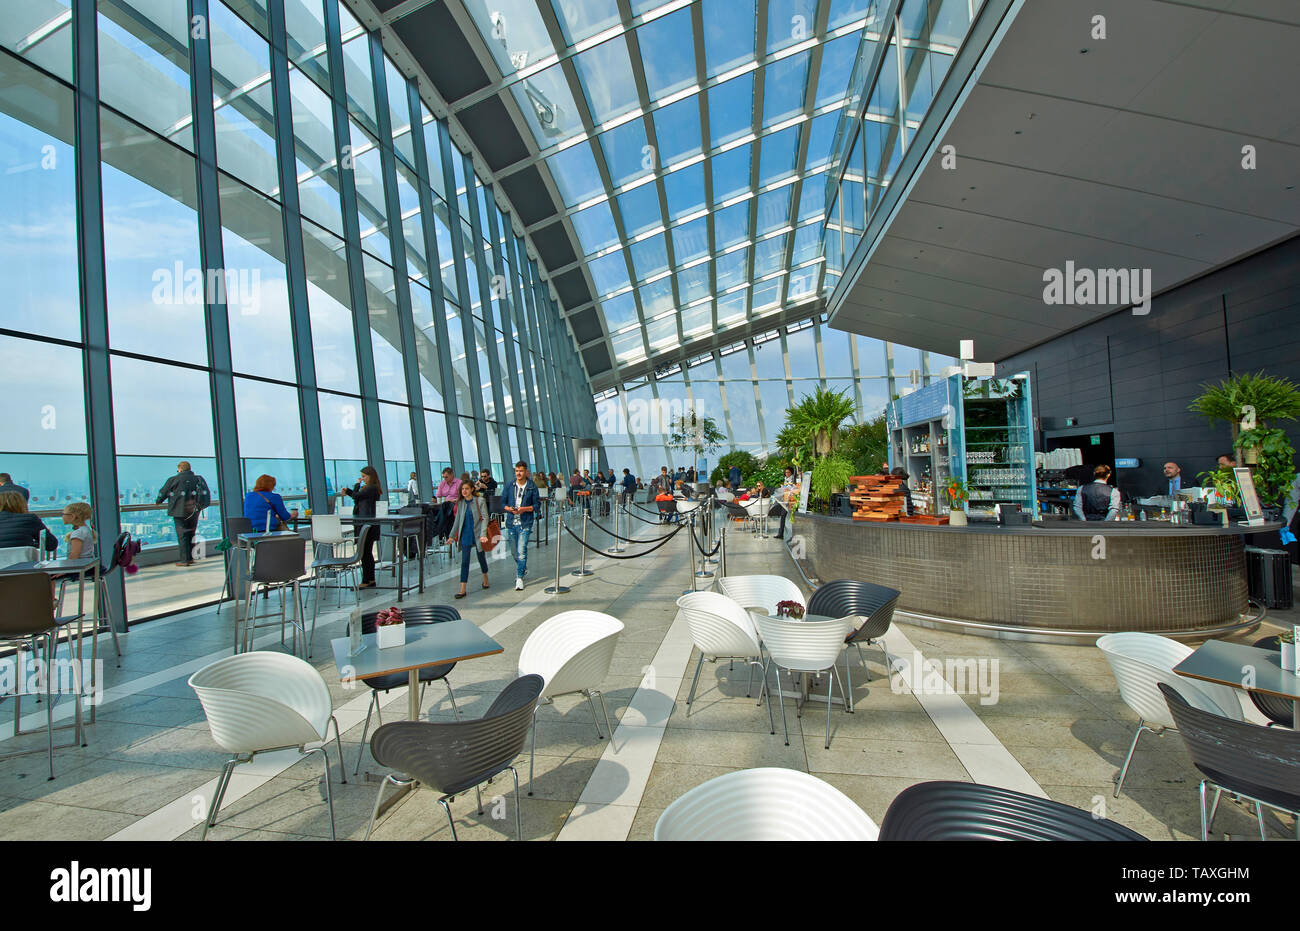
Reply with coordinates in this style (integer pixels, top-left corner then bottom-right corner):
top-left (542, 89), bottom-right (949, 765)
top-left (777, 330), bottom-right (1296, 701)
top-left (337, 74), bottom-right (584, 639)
top-left (365, 675), bottom-right (545, 840)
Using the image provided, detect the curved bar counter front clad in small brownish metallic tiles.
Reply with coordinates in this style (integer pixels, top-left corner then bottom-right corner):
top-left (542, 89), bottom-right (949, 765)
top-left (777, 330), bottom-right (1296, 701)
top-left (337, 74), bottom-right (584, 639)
top-left (794, 514), bottom-right (1281, 642)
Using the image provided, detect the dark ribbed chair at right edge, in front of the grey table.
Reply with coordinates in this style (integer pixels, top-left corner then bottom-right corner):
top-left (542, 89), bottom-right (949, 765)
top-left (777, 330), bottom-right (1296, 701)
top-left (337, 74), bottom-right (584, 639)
top-left (1157, 683), bottom-right (1300, 840)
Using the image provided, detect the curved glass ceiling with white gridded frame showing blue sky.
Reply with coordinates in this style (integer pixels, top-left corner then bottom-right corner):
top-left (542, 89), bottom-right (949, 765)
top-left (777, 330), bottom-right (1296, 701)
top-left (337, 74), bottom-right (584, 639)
top-left (458, 0), bottom-right (879, 377)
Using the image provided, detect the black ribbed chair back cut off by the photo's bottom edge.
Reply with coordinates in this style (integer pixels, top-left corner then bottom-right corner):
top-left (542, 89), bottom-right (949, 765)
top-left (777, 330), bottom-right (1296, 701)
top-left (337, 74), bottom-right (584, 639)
top-left (880, 781), bottom-right (1147, 840)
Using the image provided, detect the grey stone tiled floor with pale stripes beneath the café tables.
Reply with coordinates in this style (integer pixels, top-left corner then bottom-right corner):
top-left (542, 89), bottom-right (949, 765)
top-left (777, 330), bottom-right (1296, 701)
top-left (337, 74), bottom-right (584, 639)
top-left (0, 509), bottom-right (1295, 840)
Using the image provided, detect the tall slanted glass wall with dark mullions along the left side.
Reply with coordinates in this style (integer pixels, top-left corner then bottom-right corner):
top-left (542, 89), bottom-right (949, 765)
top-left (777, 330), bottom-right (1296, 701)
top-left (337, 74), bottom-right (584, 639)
top-left (0, 0), bottom-right (594, 620)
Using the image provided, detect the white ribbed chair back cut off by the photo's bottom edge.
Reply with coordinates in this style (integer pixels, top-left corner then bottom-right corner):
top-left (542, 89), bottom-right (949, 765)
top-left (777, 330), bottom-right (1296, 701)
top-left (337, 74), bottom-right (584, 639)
top-left (654, 767), bottom-right (880, 841)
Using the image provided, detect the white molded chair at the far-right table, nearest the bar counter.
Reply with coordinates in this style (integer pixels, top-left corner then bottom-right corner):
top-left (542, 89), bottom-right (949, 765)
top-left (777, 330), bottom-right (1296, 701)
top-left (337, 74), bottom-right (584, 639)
top-left (1097, 631), bottom-right (1244, 798)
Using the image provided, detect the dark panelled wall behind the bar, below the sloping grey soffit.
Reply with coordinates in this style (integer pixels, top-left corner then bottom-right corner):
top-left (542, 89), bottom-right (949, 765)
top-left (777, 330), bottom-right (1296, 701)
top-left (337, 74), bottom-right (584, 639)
top-left (998, 237), bottom-right (1300, 504)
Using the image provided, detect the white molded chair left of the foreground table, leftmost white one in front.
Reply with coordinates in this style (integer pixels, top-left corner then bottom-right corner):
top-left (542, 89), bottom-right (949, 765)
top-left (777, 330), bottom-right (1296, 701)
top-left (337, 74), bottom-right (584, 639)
top-left (190, 650), bottom-right (347, 840)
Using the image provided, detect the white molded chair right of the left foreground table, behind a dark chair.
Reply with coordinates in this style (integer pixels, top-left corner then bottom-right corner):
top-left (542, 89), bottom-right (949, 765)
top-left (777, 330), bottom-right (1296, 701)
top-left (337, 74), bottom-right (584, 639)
top-left (519, 611), bottom-right (623, 794)
